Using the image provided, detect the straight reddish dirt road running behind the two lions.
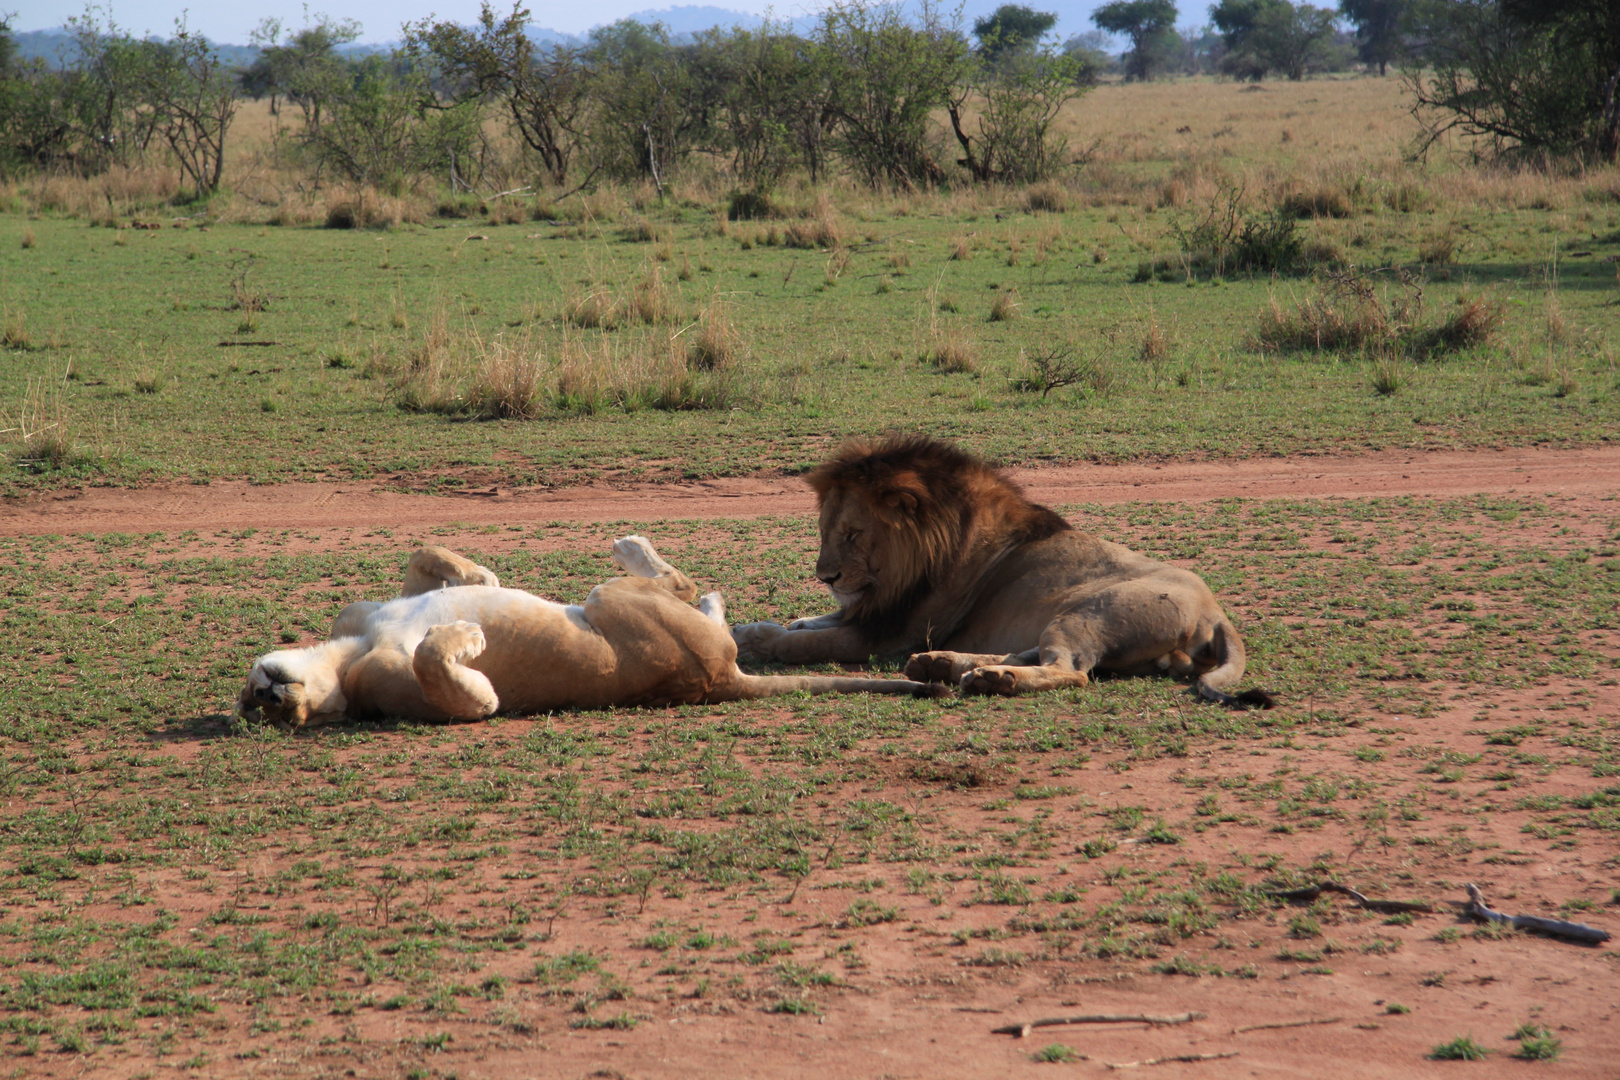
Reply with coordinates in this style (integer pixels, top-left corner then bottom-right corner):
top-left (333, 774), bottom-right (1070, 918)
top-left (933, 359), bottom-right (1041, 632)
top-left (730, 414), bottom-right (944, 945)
top-left (0, 447), bottom-right (1620, 536)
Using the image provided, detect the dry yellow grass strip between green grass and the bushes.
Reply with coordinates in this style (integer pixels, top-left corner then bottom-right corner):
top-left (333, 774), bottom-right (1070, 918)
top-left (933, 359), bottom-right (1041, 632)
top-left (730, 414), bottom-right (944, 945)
top-left (0, 83), bottom-right (1620, 228)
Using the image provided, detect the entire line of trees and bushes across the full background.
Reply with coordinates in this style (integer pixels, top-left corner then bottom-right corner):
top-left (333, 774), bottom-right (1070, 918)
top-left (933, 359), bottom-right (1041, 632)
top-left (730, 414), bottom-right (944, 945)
top-left (0, 0), bottom-right (1620, 198)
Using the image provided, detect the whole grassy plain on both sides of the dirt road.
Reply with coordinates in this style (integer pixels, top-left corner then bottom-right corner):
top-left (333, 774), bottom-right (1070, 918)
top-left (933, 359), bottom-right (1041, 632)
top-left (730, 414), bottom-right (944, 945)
top-left (0, 78), bottom-right (1620, 1078)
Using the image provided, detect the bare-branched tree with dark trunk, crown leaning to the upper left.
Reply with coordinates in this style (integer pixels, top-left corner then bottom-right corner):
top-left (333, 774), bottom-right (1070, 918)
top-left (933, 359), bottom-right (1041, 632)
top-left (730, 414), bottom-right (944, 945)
top-left (405, 0), bottom-right (590, 186)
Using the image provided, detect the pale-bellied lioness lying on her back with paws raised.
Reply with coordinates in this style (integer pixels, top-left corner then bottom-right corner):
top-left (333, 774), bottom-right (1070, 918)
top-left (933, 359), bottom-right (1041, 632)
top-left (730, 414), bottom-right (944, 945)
top-left (240, 536), bottom-right (932, 727)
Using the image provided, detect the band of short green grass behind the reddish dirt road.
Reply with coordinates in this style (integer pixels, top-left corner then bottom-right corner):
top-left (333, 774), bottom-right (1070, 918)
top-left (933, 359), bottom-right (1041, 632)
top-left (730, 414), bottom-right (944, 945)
top-left (0, 194), bottom-right (1620, 491)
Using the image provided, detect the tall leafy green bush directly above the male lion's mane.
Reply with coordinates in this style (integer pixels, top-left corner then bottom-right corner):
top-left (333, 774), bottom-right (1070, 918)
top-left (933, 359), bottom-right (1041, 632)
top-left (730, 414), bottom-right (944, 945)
top-left (815, 0), bottom-right (969, 188)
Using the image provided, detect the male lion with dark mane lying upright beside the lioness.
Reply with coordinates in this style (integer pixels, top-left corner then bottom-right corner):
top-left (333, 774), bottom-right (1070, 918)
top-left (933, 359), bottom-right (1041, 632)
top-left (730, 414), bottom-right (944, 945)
top-left (732, 436), bottom-right (1272, 708)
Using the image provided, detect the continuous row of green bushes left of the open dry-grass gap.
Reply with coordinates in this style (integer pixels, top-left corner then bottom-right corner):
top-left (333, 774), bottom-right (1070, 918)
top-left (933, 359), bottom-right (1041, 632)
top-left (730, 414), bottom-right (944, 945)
top-left (0, 2), bottom-right (1089, 196)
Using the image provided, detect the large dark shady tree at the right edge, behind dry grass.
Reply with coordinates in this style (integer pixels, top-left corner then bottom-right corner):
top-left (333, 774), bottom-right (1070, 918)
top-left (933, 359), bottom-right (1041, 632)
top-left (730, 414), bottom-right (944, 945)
top-left (1409, 0), bottom-right (1620, 162)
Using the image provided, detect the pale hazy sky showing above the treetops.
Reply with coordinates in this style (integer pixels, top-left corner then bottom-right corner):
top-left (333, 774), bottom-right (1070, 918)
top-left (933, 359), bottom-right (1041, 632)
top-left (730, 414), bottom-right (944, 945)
top-left (12, 0), bottom-right (1153, 45)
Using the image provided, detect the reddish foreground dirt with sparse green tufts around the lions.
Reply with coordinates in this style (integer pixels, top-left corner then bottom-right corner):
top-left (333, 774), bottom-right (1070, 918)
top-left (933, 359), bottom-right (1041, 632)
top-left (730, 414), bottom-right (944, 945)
top-left (0, 452), bottom-right (1620, 1080)
